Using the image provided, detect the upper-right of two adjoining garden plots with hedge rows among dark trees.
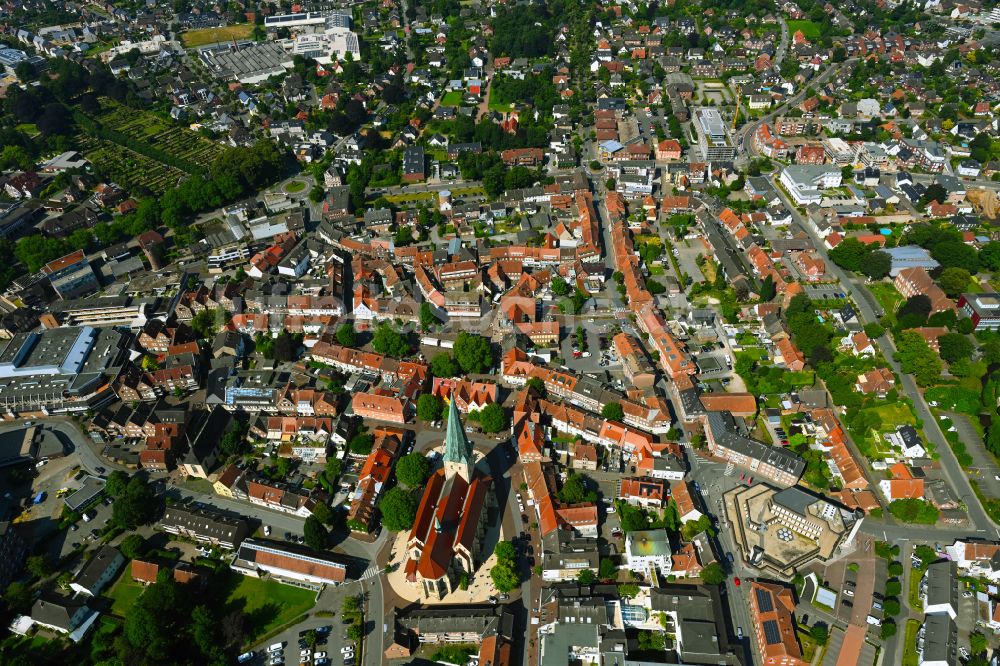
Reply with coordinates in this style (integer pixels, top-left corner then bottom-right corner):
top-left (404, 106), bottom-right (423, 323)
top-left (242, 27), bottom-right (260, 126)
top-left (96, 99), bottom-right (225, 168)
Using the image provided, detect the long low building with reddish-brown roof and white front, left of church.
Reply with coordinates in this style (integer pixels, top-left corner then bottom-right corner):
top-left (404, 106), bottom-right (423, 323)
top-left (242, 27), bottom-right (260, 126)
top-left (231, 539), bottom-right (347, 588)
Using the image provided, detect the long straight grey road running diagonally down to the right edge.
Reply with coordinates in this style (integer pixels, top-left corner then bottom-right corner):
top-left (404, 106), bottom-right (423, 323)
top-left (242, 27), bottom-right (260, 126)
top-left (772, 177), bottom-right (1000, 536)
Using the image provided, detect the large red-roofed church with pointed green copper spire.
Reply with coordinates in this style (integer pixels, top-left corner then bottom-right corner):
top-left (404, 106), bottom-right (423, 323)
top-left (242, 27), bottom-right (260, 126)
top-left (405, 400), bottom-right (497, 599)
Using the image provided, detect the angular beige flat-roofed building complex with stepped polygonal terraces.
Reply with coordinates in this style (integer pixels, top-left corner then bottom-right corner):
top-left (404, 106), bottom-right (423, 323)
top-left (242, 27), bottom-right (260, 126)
top-left (723, 483), bottom-right (863, 580)
